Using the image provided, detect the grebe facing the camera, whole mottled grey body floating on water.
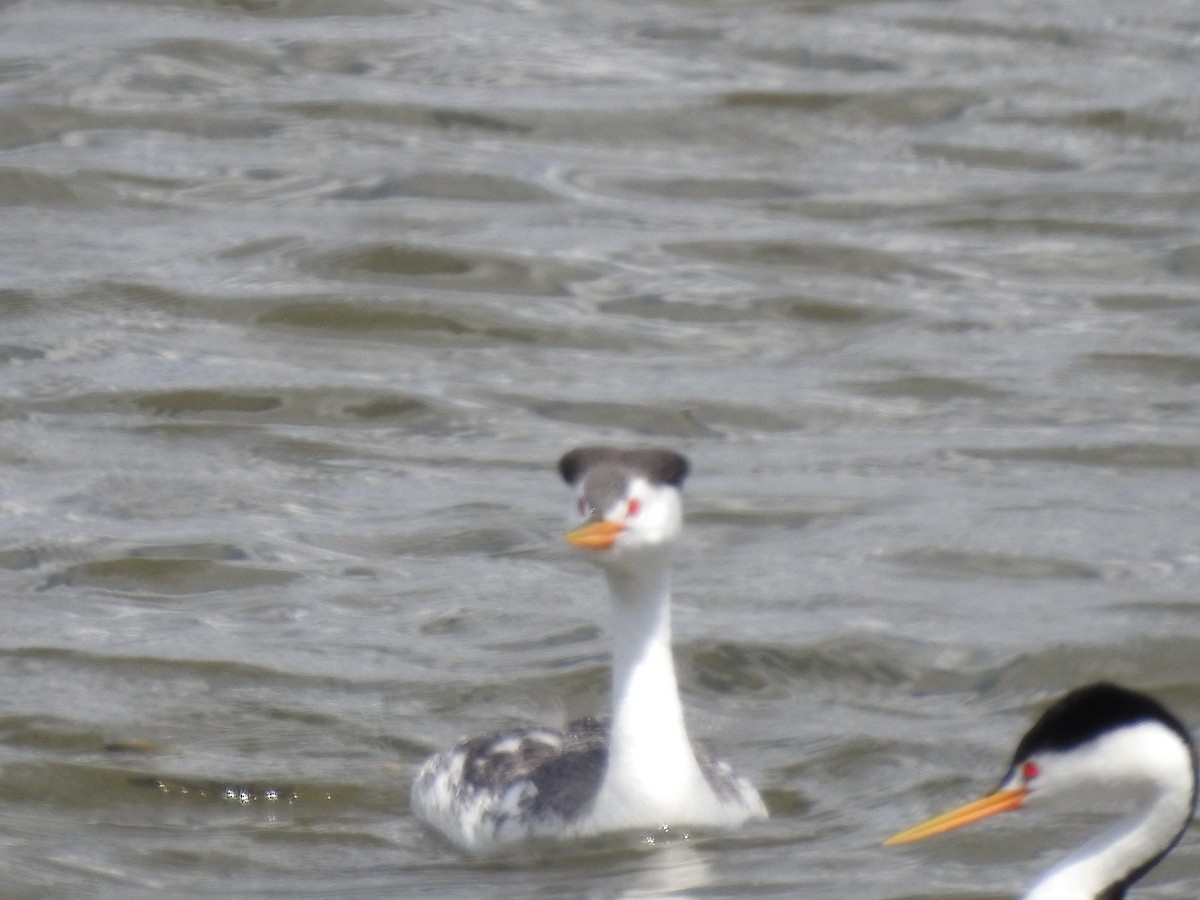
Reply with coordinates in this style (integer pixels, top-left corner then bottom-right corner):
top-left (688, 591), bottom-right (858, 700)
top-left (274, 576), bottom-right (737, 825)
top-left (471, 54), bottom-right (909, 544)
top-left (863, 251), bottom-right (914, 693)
top-left (413, 446), bottom-right (767, 852)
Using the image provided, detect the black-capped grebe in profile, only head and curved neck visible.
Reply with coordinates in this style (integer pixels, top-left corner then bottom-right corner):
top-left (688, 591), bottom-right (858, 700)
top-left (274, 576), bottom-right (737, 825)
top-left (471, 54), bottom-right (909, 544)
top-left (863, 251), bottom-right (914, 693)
top-left (884, 683), bottom-right (1196, 900)
